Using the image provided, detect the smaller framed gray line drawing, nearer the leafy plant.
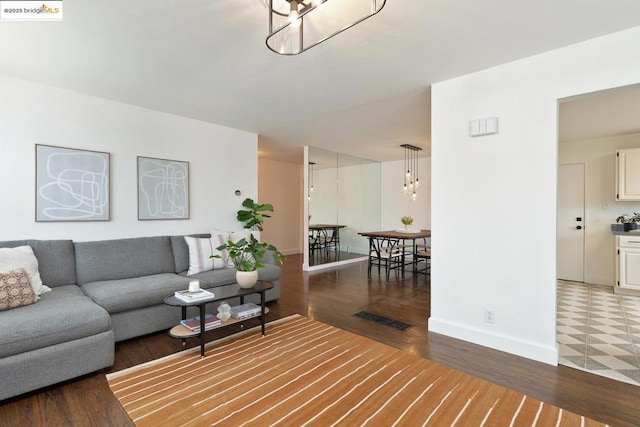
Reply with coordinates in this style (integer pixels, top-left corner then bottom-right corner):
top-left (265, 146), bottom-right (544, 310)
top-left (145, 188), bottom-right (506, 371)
top-left (138, 156), bottom-right (189, 220)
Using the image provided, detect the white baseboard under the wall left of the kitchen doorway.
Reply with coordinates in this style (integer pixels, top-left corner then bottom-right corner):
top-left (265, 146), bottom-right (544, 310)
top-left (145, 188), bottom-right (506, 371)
top-left (429, 317), bottom-right (559, 366)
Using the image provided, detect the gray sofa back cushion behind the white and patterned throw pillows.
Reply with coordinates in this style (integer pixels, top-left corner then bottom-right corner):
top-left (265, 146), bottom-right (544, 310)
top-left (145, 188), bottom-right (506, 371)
top-left (0, 240), bottom-right (76, 287)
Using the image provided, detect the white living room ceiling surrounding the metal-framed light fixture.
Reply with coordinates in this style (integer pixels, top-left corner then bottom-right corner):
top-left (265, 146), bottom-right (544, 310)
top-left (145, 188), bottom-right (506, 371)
top-left (0, 0), bottom-right (640, 161)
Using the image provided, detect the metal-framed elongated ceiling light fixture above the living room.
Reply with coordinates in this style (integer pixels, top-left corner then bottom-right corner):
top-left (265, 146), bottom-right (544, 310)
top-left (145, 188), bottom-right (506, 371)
top-left (265, 0), bottom-right (386, 55)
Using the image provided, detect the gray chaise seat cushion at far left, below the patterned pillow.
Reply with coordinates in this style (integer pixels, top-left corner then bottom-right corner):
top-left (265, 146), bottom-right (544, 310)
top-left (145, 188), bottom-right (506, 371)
top-left (0, 285), bottom-right (111, 357)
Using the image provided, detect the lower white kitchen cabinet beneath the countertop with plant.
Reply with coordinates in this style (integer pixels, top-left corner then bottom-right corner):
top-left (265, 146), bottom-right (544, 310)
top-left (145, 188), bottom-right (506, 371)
top-left (615, 234), bottom-right (640, 295)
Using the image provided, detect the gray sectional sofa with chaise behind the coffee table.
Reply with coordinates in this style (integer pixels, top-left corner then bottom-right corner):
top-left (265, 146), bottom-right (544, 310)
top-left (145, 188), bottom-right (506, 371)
top-left (0, 234), bottom-right (280, 400)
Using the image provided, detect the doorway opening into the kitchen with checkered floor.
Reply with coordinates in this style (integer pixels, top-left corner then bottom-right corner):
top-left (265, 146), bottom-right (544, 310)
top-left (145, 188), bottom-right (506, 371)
top-left (556, 85), bottom-right (640, 386)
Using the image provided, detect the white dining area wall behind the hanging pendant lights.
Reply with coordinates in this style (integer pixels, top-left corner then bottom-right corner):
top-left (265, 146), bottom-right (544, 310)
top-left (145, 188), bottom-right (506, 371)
top-left (380, 157), bottom-right (431, 230)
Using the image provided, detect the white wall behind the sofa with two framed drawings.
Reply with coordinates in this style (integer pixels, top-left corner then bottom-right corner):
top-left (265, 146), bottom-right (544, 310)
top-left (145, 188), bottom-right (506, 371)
top-left (0, 77), bottom-right (257, 240)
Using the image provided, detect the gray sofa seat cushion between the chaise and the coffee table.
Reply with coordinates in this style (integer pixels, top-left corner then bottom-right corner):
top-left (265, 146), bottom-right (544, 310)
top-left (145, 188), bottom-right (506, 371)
top-left (82, 273), bottom-right (191, 313)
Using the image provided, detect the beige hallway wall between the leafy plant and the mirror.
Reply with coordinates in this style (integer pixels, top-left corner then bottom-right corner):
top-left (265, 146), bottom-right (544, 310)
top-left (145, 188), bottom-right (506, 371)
top-left (258, 158), bottom-right (304, 255)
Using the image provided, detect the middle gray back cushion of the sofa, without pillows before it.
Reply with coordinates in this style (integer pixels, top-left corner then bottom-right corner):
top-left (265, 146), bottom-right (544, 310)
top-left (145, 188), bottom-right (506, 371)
top-left (74, 236), bottom-right (175, 285)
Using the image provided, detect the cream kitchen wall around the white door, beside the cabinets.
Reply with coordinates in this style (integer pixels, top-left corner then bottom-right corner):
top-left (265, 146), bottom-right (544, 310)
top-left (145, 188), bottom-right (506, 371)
top-left (558, 134), bottom-right (640, 286)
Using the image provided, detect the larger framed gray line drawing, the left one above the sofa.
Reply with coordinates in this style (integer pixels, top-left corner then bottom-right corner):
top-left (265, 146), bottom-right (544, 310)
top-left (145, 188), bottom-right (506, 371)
top-left (36, 144), bottom-right (110, 222)
